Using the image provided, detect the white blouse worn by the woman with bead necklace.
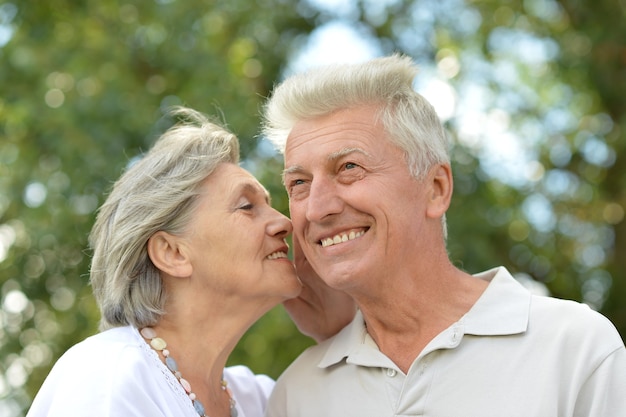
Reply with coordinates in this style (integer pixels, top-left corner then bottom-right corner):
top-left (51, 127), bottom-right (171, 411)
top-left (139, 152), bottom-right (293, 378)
top-left (27, 326), bottom-right (274, 417)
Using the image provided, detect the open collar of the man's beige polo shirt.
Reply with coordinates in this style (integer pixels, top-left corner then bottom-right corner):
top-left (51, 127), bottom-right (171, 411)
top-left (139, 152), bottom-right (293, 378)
top-left (318, 267), bottom-right (531, 368)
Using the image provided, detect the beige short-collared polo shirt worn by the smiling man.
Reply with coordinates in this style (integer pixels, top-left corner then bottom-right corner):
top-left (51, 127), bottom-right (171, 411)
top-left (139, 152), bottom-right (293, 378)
top-left (266, 267), bottom-right (626, 417)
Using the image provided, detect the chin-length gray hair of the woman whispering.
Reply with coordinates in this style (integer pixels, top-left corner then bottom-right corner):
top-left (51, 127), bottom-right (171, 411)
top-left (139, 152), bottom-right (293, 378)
top-left (89, 107), bottom-right (239, 330)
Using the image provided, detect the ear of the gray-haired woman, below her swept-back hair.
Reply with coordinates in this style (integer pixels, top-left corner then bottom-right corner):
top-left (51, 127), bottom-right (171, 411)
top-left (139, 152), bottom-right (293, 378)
top-left (148, 231), bottom-right (193, 278)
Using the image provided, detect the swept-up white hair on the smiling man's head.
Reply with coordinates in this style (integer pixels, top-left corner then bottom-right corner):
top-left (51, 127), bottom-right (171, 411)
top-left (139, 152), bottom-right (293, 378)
top-left (262, 54), bottom-right (450, 178)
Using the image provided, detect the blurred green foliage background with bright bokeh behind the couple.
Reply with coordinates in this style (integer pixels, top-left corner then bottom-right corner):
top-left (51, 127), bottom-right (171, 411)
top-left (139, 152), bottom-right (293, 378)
top-left (0, 0), bottom-right (626, 417)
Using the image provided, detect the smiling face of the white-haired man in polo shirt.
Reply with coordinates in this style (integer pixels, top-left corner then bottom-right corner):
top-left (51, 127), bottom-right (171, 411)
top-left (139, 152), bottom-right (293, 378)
top-left (284, 106), bottom-right (427, 295)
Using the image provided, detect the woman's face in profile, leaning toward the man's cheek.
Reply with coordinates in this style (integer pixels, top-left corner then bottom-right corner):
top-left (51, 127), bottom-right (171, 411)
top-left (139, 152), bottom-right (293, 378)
top-left (183, 163), bottom-right (301, 303)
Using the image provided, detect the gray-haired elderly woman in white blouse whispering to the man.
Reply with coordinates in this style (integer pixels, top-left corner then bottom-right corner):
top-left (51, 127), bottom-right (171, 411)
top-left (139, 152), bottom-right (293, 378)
top-left (28, 109), bottom-right (349, 417)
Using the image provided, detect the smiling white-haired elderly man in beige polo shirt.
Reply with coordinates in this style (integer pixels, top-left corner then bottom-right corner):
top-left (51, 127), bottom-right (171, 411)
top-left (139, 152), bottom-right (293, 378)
top-left (264, 55), bottom-right (626, 417)
